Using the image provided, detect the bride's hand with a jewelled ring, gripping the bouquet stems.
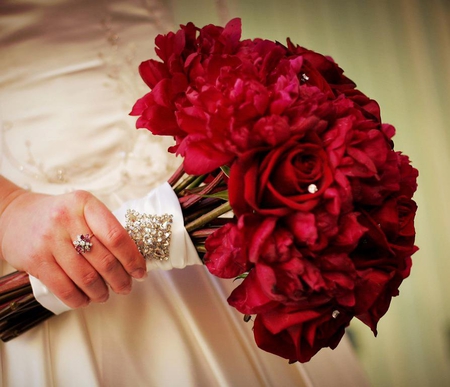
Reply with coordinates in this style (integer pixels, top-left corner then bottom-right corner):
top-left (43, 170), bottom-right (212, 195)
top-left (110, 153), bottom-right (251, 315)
top-left (0, 178), bottom-right (146, 308)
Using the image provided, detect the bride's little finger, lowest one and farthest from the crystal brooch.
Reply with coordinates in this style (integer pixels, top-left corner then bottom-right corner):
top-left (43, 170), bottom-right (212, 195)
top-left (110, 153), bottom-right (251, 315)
top-left (30, 257), bottom-right (90, 309)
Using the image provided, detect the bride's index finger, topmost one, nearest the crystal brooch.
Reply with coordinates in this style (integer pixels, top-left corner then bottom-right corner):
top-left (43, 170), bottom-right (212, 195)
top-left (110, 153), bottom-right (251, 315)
top-left (84, 200), bottom-right (147, 279)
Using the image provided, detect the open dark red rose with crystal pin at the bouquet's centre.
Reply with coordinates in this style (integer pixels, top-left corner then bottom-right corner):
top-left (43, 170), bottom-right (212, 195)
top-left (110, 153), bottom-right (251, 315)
top-left (232, 134), bottom-right (333, 216)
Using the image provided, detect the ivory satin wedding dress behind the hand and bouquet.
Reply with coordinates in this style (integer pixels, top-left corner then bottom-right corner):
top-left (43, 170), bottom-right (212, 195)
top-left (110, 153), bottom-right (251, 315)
top-left (0, 0), bottom-right (367, 387)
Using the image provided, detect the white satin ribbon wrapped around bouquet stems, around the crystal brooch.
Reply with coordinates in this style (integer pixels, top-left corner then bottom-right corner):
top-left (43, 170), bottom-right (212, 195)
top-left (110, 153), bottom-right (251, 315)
top-left (30, 183), bottom-right (202, 314)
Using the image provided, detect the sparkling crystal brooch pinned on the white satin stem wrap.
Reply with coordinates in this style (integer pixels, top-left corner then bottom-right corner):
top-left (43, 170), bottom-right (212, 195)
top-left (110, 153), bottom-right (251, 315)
top-left (125, 210), bottom-right (173, 261)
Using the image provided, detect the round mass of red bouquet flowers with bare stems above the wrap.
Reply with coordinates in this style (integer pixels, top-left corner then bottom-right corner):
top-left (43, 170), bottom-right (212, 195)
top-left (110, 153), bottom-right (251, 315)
top-left (0, 19), bottom-right (418, 362)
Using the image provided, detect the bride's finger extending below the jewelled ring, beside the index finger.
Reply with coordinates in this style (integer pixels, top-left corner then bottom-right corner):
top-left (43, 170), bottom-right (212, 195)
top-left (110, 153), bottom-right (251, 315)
top-left (78, 236), bottom-right (132, 294)
